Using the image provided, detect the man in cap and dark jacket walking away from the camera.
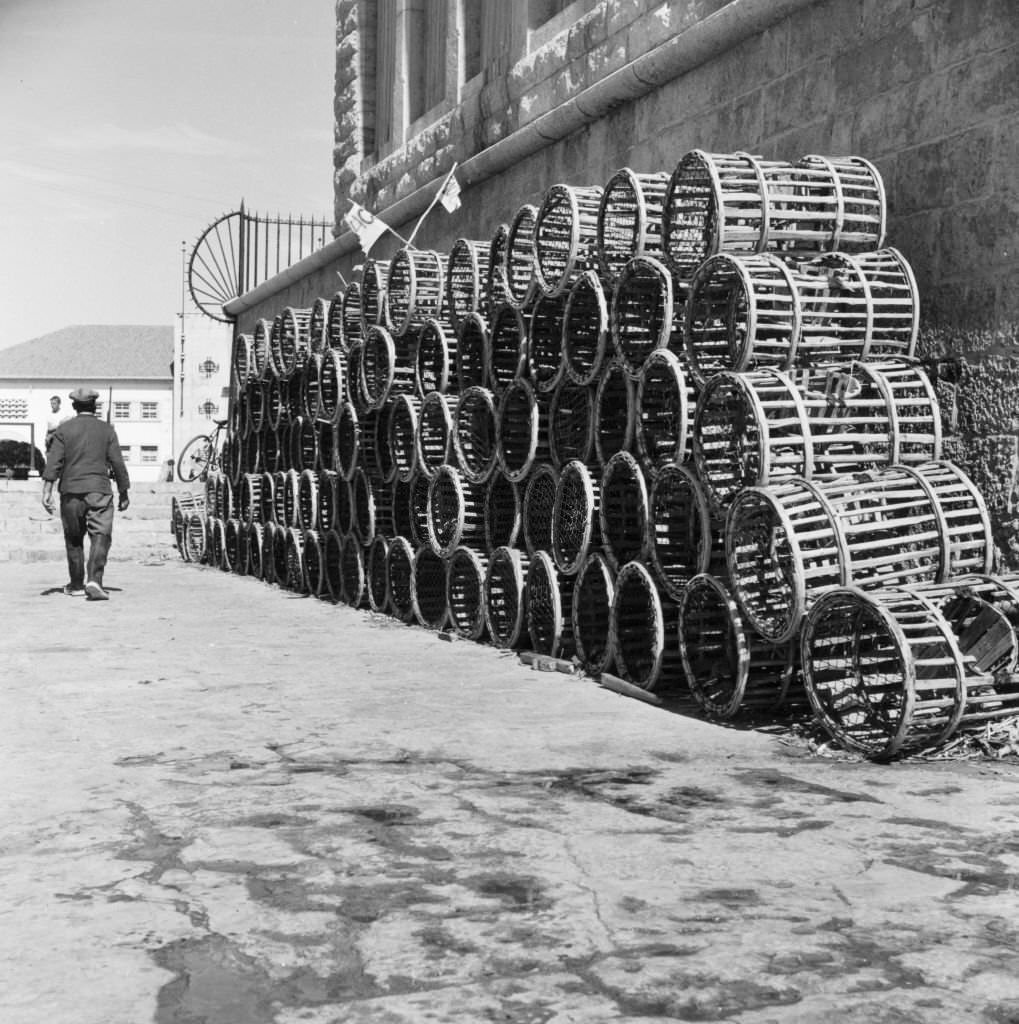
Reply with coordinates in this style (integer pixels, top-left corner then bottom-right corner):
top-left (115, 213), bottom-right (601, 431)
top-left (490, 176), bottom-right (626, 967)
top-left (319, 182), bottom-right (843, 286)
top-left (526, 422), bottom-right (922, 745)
top-left (42, 387), bottom-right (131, 601)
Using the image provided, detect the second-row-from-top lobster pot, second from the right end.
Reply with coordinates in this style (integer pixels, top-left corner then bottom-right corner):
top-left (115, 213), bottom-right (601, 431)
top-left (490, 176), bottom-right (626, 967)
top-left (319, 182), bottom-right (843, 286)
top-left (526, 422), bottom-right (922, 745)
top-left (608, 256), bottom-right (682, 380)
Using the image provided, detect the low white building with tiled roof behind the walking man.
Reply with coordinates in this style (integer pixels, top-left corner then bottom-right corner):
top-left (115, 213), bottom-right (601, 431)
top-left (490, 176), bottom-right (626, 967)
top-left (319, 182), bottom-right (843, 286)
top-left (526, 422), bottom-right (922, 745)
top-left (0, 325), bottom-right (174, 482)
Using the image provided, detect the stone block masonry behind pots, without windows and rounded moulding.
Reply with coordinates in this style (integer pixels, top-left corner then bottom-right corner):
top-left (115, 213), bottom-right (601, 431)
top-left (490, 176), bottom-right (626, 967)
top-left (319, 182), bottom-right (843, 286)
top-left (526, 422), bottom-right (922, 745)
top-left (241, 0), bottom-right (1019, 564)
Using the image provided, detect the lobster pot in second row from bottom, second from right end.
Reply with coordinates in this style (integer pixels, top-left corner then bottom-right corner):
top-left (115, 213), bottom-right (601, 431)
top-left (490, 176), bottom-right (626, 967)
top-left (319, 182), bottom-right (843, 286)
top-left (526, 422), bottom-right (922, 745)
top-left (647, 466), bottom-right (725, 601)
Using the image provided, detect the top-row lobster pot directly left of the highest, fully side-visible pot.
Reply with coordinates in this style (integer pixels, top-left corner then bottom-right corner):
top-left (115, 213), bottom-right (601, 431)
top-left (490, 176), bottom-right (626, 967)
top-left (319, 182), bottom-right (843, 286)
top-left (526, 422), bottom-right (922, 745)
top-left (596, 167), bottom-right (669, 285)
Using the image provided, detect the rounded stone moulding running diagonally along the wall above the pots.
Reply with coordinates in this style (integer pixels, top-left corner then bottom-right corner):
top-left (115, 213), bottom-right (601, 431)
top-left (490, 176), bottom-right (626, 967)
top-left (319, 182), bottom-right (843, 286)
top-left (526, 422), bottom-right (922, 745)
top-left (223, 0), bottom-right (819, 316)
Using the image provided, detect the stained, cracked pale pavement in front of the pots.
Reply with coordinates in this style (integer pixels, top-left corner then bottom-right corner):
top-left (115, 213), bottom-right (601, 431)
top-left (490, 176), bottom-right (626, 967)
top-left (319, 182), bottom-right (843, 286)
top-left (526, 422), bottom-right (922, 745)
top-left (0, 560), bottom-right (1019, 1024)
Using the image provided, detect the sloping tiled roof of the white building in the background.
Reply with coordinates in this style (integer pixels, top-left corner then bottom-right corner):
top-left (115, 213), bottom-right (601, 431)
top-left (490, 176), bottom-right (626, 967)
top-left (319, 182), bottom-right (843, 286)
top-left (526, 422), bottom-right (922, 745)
top-left (0, 324), bottom-right (173, 381)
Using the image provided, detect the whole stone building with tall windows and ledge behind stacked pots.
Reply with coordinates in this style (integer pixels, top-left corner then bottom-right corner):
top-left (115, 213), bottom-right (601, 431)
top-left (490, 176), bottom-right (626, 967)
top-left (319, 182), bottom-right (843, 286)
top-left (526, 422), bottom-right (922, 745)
top-left (227, 0), bottom-right (1019, 564)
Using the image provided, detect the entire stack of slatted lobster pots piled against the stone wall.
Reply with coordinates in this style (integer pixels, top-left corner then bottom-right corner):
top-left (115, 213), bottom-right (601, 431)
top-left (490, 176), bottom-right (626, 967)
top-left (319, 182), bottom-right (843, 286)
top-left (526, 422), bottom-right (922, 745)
top-left (181, 151), bottom-right (1019, 757)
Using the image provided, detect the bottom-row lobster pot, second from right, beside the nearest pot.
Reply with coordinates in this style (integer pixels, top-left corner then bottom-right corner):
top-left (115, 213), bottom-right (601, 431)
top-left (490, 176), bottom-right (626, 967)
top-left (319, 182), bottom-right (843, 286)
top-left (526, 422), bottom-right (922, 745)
top-left (678, 572), bottom-right (806, 721)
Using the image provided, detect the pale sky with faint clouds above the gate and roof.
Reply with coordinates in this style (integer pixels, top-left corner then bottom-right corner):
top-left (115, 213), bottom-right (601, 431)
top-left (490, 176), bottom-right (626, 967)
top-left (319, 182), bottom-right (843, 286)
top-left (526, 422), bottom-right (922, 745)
top-left (0, 0), bottom-right (336, 348)
